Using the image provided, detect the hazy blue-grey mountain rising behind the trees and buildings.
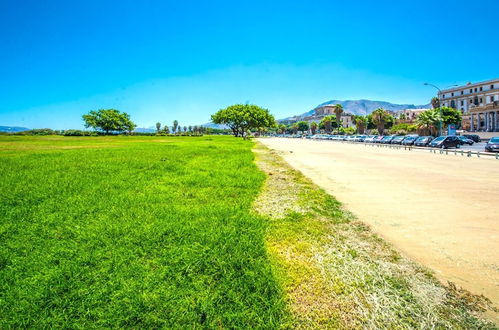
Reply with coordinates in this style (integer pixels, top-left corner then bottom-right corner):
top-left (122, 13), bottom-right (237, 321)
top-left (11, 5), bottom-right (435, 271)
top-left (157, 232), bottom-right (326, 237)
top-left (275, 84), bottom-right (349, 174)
top-left (280, 100), bottom-right (431, 120)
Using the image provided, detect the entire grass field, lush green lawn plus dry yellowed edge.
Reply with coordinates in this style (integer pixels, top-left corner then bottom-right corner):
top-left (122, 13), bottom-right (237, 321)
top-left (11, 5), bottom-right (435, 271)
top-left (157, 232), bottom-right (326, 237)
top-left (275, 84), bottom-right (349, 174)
top-left (0, 136), bottom-right (496, 329)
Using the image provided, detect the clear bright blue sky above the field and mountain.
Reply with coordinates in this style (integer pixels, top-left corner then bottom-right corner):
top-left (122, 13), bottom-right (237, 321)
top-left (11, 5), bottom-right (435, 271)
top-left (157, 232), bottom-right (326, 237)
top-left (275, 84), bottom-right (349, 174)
top-left (0, 0), bottom-right (499, 129)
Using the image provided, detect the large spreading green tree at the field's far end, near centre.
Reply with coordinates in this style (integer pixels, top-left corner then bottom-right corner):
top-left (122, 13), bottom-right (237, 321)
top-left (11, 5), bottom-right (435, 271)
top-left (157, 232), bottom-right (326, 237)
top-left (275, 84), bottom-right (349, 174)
top-left (211, 104), bottom-right (276, 137)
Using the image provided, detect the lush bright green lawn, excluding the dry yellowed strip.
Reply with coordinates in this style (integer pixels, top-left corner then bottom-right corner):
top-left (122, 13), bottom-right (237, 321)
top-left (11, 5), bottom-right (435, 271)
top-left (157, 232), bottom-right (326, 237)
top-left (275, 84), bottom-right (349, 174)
top-left (0, 136), bottom-right (287, 328)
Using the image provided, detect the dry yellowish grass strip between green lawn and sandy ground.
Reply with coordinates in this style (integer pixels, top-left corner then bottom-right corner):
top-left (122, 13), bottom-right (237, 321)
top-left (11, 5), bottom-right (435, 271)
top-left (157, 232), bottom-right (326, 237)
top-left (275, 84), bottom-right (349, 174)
top-left (254, 144), bottom-right (495, 329)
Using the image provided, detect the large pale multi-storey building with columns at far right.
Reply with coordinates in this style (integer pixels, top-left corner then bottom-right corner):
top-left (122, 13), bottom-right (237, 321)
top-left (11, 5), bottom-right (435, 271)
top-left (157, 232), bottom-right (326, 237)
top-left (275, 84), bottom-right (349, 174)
top-left (438, 79), bottom-right (499, 132)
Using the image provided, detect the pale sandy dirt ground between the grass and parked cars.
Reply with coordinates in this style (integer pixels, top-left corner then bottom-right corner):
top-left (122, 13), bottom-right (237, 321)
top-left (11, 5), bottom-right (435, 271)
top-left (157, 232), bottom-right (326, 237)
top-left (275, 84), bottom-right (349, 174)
top-left (260, 138), bottom-right (499, 318)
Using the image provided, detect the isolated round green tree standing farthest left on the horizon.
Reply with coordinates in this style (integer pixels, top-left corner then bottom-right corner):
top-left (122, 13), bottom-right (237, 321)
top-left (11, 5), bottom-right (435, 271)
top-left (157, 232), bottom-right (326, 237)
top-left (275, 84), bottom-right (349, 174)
top-left (82, 109), bottom-right (136, 134)
